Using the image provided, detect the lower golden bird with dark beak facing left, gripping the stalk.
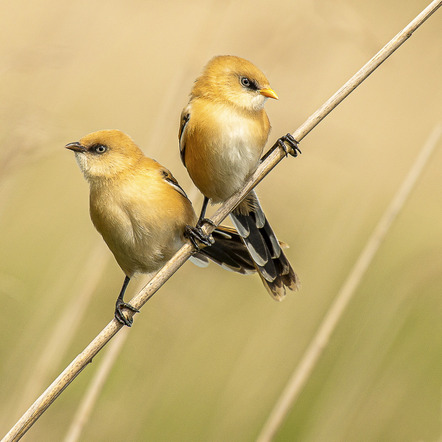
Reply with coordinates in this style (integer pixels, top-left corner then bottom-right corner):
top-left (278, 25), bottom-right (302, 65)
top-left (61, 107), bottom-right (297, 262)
top-left (66, 130), bottom-right (255, 326)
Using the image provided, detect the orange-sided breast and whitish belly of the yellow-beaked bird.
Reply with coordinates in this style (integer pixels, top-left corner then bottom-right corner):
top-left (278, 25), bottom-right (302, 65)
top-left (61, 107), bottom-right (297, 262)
top-left (184, 100), bottom-right (270, 203)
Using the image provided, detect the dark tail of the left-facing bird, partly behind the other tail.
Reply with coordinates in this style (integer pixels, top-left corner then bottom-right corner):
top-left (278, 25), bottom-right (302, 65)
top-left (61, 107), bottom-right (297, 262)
top-left (190, 226), bottom-right (256, 274)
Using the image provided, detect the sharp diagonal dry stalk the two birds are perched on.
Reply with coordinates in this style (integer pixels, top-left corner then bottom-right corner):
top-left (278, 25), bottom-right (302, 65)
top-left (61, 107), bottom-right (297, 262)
top-left (2, 0), bottom-right (442, 442)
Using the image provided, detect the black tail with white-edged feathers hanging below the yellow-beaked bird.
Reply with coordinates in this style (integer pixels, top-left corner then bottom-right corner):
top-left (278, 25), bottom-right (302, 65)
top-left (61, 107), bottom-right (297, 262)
top-left (230, 191), bottom-right (299, 301)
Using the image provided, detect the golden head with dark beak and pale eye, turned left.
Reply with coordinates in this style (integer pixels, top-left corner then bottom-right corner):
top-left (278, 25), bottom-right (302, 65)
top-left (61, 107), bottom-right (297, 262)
top-left (65, 130), bottom-right (143, 181)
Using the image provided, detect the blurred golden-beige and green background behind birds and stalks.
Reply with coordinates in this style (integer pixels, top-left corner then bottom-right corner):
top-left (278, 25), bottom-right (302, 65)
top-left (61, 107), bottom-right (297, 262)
top-left (0, 0), bottom-right (442, 441)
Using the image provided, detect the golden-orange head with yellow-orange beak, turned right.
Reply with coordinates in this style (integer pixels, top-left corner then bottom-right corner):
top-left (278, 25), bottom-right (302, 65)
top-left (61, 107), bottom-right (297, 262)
top-left (192, 55), bottom-right (278, 112)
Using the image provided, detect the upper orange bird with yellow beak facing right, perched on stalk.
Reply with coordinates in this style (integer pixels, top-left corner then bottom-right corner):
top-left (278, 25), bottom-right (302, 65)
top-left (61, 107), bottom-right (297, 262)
top-left (179, 55), bottom-right (300, 301)
